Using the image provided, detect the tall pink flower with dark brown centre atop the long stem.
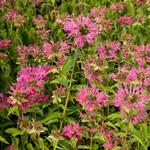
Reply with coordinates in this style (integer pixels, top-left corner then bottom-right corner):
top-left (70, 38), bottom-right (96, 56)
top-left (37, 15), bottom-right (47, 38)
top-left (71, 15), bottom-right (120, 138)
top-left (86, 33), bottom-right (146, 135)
top-left (64, 16), bottom-right (98, 48)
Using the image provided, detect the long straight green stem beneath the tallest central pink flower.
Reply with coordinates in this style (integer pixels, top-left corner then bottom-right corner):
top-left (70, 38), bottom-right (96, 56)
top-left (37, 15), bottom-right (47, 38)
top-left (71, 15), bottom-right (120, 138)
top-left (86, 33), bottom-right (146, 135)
top-left (60, 48), bottom-right (78, 130)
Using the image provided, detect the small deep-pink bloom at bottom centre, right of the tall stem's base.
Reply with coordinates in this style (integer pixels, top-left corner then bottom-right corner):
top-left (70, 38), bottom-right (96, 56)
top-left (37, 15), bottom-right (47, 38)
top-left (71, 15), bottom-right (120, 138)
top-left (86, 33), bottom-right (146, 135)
top-left (62, 123), bottom-right (81, 139)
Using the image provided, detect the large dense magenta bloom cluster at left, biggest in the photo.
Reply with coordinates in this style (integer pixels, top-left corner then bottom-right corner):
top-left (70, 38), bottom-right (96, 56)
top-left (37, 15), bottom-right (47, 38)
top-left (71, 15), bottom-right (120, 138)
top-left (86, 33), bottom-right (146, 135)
top-left (8, 66), bottom-right (51, 109)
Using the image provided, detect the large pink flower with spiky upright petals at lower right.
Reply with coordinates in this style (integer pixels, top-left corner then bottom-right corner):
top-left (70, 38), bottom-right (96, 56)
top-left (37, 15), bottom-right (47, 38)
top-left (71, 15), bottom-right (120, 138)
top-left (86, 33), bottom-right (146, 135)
top-left (114, 84), bottom-right (148, 122)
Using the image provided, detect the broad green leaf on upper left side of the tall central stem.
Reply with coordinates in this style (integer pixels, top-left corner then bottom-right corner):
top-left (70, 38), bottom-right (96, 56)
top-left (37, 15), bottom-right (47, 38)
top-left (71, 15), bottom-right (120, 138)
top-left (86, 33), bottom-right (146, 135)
top-left (61, 57), bottom-right (74, 76)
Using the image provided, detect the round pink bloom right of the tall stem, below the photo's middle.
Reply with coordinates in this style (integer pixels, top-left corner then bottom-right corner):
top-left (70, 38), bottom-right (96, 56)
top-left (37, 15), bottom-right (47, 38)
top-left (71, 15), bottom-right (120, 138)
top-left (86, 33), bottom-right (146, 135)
top-left (76, 86), bottom-right (107, 112)
